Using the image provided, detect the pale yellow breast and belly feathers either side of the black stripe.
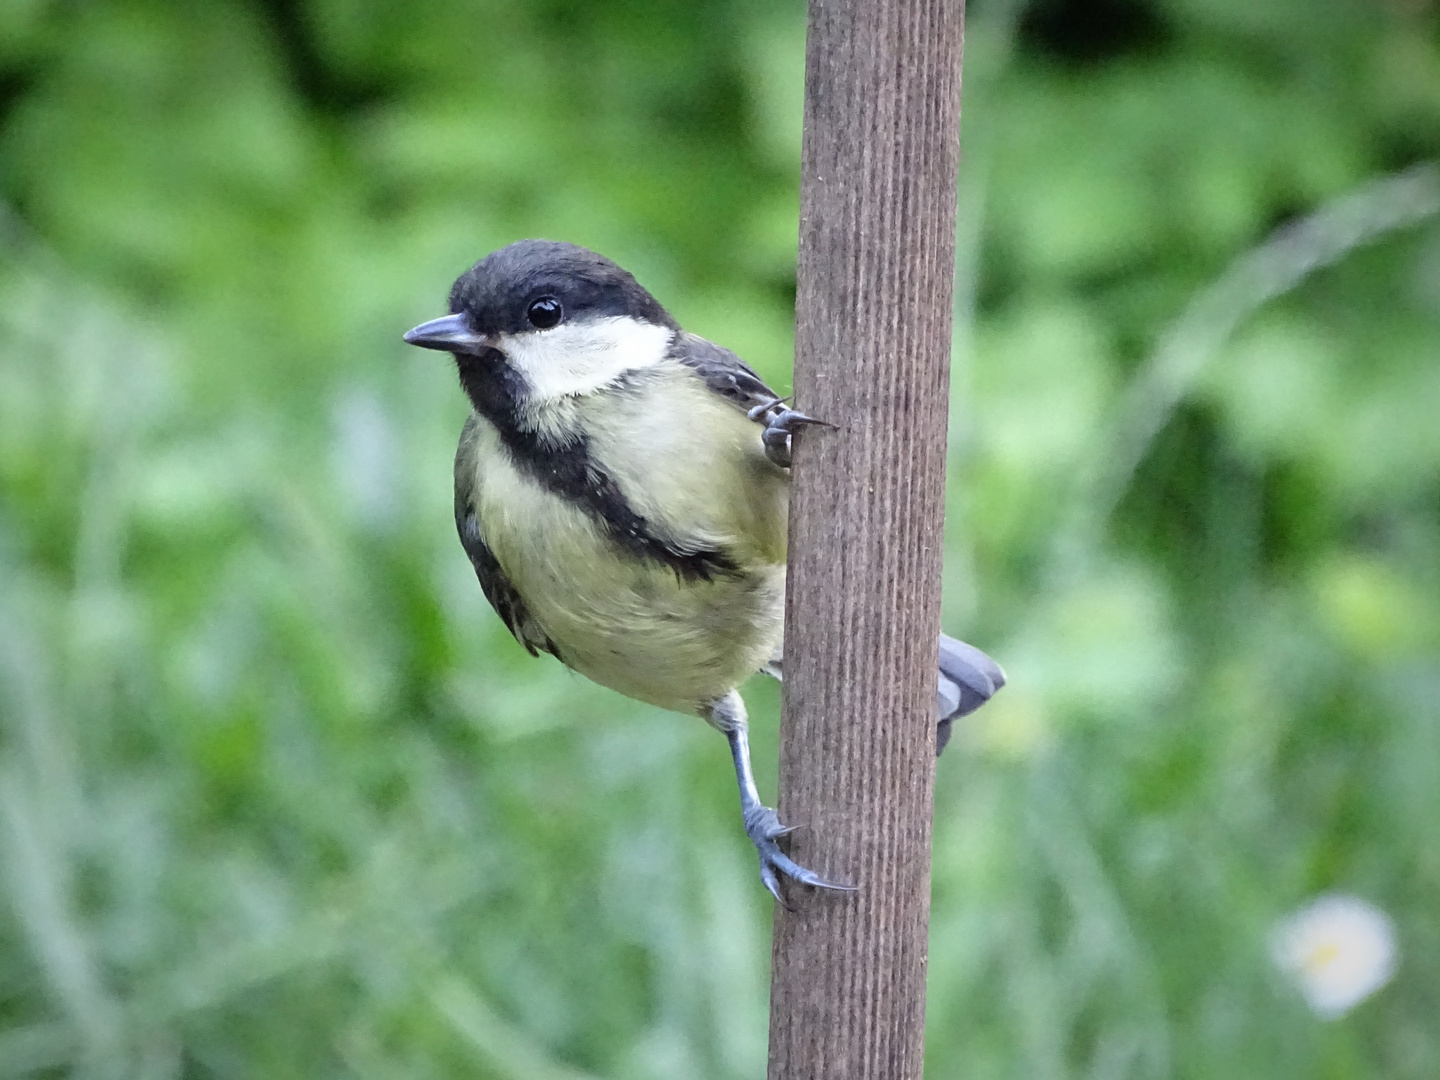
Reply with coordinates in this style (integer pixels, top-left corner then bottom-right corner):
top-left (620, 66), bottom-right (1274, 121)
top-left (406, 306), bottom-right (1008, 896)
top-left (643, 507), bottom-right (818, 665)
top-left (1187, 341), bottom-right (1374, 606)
top-left (456, 363), bottom-right (788, 711)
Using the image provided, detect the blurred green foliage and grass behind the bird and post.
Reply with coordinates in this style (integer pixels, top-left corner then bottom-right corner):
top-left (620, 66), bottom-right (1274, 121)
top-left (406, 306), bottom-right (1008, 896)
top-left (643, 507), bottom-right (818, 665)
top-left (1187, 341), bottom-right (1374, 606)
top-left (0, 0), bottom-right (1440, 1080)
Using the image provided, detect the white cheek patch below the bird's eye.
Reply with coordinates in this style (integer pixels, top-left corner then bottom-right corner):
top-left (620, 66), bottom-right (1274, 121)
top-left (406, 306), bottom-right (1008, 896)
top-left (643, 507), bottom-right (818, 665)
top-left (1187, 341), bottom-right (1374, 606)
top-left (497, 324), bottom-right (675, 402)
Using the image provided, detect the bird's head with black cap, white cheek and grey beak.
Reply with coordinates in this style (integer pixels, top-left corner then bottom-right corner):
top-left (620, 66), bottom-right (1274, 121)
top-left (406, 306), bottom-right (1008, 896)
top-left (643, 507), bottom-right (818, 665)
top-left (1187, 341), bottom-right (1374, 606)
top-left (405, 240), bottom-right (678, 412)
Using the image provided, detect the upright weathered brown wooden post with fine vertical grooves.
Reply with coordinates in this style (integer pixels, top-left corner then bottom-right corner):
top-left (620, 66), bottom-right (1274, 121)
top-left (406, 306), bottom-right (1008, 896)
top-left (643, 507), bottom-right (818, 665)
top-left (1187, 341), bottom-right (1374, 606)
top-left (769, 0), bottom-right (965, 1080)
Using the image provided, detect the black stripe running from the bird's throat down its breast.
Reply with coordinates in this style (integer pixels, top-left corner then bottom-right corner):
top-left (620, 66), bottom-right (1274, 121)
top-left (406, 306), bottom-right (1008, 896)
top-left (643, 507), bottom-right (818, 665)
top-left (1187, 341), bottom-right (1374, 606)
top-left (456, 353), bottom-right (740, 582)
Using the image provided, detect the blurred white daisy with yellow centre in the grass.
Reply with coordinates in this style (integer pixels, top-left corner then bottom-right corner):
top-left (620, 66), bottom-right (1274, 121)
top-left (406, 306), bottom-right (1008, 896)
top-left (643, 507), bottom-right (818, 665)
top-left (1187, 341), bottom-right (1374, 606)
top-left (1270, 894), bottom-right (1395, 1020)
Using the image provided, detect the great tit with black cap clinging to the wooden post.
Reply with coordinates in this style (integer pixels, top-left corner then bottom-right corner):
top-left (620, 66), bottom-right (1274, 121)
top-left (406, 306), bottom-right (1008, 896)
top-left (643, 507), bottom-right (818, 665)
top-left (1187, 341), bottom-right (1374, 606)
top-left (405, 239), bottom-right (1005, 903)
